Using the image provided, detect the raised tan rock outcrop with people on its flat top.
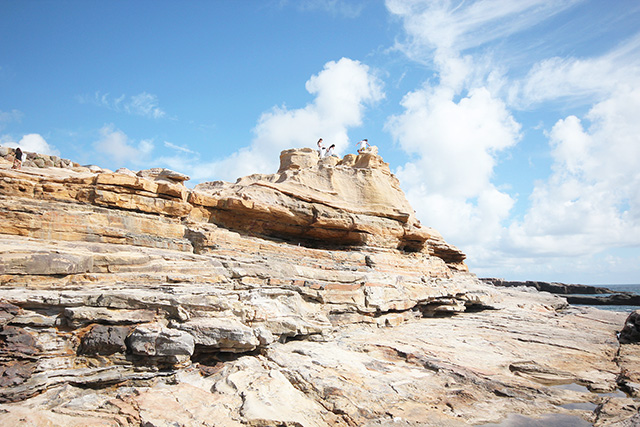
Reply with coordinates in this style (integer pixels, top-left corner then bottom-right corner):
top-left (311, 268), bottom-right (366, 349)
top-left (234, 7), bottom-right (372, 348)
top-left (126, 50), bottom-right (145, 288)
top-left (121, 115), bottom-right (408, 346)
top-left (192, 148), bottom-right (466, 270)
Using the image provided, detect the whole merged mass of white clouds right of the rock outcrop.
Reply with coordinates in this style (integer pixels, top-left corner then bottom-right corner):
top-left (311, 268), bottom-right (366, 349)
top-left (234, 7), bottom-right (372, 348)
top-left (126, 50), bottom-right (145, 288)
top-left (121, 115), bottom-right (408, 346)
top-left (386, 0), bottom-right (640, 284)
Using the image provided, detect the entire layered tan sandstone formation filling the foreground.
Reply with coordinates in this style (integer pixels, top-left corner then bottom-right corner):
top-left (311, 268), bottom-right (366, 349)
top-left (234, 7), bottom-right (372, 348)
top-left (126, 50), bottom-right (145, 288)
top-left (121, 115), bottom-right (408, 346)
top-left (0, 149), bottom-right (640, 426)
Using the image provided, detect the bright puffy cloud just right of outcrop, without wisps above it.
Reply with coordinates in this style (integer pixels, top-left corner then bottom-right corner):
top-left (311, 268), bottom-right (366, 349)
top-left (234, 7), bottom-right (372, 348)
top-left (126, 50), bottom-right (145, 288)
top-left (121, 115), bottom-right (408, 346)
top-left (387, 88), bottom-right (520, 249)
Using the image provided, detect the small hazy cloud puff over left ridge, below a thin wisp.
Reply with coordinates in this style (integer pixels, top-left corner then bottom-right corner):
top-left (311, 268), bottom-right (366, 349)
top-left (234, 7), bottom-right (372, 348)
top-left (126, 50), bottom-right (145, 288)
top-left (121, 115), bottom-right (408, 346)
top-left (93, 124), bottom-right (154, 167)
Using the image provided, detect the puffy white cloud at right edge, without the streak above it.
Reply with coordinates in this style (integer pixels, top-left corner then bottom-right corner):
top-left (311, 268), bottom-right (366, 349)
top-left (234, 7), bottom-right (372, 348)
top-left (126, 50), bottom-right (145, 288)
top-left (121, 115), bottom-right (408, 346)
top-left (509, 85), bottom-right (640, 255)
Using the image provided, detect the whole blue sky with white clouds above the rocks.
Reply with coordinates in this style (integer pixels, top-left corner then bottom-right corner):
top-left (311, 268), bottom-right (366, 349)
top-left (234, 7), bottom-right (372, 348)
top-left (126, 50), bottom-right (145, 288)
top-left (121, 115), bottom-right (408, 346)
top-left (0, 0), bottom-right (640, 284)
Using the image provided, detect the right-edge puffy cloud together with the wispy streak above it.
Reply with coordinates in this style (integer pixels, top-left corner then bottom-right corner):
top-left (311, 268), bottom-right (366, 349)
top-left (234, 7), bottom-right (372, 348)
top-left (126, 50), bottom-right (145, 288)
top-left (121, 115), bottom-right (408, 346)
top-left (504, 30), bottom-right (640, 268)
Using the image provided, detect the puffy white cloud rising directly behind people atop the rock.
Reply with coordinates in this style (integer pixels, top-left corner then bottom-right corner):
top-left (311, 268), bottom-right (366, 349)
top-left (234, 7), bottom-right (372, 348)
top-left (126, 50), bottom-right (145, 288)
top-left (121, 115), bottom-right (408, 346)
top-left (191, 58), bottom-right (384, 181)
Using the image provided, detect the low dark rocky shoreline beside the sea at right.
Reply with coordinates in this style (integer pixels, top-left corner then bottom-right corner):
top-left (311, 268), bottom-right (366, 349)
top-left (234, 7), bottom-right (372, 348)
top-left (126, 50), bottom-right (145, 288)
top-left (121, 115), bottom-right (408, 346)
top-left (480, 278), bottom-right (640, 306)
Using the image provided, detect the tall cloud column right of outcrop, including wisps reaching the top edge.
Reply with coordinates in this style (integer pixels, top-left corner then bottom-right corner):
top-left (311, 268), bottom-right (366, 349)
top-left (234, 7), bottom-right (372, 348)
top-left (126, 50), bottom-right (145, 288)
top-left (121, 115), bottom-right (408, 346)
top-left (386, 0), bottom-right (524, 256)
